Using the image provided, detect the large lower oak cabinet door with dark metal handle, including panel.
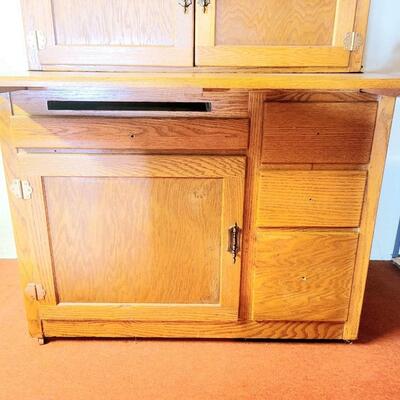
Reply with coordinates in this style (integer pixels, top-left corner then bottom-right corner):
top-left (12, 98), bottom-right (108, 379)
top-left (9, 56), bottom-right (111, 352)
top-left (19, 154), bottom-right (245, 321)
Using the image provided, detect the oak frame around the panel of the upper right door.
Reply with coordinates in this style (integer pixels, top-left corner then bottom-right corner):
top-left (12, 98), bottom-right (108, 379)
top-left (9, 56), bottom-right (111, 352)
top-left (195, 0), bottom-right (370, 71)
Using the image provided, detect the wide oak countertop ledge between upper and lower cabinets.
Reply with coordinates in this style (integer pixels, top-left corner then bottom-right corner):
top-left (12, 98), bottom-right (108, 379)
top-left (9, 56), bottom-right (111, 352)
top-left (0, 72), bottom-right (400, 96)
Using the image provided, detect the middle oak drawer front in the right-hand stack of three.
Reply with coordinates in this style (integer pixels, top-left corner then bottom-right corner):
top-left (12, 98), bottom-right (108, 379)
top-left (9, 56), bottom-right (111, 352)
top-left (257, 171), bottom-right (367, 227)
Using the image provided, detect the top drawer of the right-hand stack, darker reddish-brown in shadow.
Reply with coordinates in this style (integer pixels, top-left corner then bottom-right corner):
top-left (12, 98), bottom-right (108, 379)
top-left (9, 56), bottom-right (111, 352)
top-left (262, 102), bottom-right (377, 164)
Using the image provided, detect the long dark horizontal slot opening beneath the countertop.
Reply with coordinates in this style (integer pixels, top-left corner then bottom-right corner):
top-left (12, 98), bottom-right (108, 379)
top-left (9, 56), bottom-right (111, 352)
top-left (47, 100), bottom-right (211, 112)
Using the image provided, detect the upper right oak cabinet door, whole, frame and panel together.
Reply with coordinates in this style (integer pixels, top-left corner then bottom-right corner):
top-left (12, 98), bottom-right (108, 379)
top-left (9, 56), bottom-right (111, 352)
top-left (196, 0), bottom-right (369, 70)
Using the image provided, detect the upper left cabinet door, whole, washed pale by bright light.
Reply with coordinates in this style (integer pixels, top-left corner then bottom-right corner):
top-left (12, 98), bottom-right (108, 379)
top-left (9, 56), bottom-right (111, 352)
top-left (22, 0), bottom-right (194, 70)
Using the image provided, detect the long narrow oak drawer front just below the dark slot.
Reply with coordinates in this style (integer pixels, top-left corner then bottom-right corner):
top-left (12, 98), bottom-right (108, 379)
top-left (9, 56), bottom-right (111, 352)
top-left (10, 116), bottom-right (249, 151)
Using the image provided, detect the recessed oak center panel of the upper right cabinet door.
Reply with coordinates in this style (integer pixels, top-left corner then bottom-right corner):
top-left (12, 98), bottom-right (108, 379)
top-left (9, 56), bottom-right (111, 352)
top-left (215, 0), bottom-right (336, 46)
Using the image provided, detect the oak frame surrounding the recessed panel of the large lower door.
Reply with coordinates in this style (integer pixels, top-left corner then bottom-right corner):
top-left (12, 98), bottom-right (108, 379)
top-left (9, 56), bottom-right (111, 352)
top-left (14, 153), bottom-right (245, 321)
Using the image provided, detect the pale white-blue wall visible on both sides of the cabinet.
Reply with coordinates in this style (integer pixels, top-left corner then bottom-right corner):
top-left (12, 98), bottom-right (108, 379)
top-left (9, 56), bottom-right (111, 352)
top-left (0, 0), bottom-right (400, 259)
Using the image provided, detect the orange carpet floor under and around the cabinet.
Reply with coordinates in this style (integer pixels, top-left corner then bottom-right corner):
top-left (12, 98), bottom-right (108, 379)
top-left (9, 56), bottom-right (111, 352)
top-left (0, 261), bottom-right (400, 400)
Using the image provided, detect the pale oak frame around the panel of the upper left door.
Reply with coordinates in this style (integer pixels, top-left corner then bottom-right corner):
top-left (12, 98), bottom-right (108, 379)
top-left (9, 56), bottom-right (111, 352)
top-left (21, 0), bottom-right (194, 70)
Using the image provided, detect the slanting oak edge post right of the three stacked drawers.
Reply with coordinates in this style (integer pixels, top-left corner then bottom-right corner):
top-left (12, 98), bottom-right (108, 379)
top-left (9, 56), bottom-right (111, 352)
top-left (343, 97), bottom-right (396, 340)
